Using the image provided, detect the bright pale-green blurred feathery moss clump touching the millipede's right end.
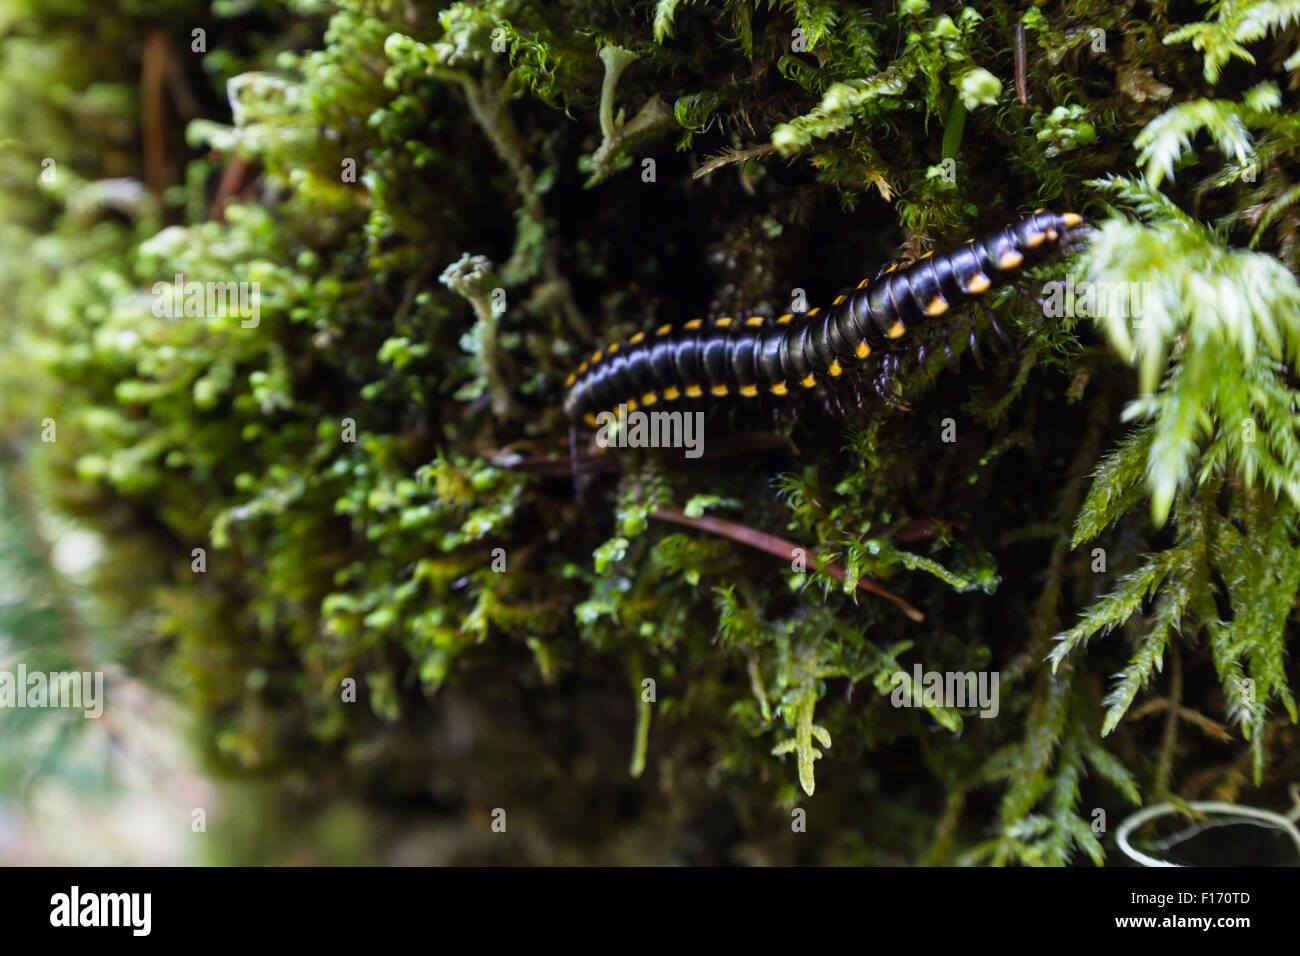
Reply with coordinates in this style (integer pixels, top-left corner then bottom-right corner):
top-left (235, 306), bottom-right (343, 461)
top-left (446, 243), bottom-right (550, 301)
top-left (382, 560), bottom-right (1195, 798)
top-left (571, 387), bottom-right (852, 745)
top-left (1079, 179), bottom-right (1300, 523)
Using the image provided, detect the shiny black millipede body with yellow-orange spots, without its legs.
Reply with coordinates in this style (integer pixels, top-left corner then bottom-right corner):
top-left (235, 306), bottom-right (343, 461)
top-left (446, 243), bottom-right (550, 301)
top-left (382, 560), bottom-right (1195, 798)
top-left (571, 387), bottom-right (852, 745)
top-left (564, 209), bottom-right (1084, 427)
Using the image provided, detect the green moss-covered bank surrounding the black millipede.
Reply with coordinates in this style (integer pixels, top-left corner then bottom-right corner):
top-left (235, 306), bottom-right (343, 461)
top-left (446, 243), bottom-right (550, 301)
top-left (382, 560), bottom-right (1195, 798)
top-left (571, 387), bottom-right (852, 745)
top-left (0, 0), bottom-right (1300, 864)
